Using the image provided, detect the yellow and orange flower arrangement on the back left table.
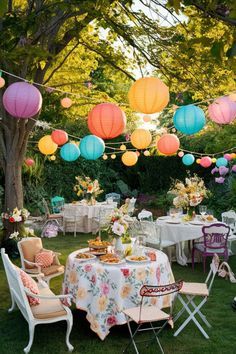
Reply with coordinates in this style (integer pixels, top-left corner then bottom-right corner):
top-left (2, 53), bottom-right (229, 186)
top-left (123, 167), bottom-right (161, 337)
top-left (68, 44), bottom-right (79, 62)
top-left (74, 176), bottom-right (103, 205)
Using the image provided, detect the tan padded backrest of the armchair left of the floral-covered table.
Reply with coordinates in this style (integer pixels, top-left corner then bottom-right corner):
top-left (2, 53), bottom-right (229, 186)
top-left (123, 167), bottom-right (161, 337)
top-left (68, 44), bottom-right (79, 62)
top-left (17, 237), bottom-right (43, 270)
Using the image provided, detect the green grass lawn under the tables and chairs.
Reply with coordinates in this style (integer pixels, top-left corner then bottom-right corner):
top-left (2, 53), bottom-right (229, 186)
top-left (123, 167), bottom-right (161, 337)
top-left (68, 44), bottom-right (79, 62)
top-left (0, 235), bottom-right (236, 354)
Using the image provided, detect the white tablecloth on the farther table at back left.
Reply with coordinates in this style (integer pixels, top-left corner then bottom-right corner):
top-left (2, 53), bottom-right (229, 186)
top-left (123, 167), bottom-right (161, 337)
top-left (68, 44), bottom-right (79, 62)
top-left (65, 202), bottom-right (117, 234)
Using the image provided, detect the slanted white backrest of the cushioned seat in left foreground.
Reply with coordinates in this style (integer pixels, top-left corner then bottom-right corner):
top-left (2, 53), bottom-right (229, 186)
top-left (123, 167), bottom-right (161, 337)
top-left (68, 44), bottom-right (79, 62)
top-left (1, 248), bottom-right (33, 321)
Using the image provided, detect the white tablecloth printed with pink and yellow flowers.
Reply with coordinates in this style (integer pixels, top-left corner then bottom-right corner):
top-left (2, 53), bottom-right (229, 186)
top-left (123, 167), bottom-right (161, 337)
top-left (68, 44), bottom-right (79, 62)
top-left (63, 249), bottom-right (174, 340)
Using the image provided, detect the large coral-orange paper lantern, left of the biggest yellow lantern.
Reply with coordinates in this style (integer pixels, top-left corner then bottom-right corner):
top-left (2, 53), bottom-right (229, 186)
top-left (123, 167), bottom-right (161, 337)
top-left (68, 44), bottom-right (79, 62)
top-left (88, 103), bottom-right (126, 139)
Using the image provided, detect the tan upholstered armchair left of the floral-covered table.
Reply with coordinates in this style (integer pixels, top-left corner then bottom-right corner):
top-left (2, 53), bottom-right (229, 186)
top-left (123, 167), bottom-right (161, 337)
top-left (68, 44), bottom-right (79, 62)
top-left (17, 237), bottom-right (64, 284)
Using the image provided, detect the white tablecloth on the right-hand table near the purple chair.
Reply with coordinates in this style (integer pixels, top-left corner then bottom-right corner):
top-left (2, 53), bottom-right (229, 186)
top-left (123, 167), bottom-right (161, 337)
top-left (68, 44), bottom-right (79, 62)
top-left (156, 216), bottom-right (217, 265)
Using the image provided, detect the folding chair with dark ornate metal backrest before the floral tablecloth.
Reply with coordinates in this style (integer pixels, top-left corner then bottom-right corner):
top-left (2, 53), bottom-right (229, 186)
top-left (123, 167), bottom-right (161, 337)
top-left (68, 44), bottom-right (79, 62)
top-left (123, 280), bottom-right (183, 354)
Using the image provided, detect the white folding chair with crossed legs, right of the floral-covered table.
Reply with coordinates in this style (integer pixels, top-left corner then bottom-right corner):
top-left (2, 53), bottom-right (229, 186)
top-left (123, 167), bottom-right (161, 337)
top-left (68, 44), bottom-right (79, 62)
top-left (174, 254), bottom-right (220, 339)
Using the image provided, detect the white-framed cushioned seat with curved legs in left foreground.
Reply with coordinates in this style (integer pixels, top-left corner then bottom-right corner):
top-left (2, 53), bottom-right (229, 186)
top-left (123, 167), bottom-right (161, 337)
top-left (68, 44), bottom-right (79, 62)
top-left (1, 248), bottom-right (74, 353)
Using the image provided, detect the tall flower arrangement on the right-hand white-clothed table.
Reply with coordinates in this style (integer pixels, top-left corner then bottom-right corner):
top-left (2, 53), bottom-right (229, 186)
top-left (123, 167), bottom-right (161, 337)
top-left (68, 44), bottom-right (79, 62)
top-left (168, 174), bottom-right (209, 208)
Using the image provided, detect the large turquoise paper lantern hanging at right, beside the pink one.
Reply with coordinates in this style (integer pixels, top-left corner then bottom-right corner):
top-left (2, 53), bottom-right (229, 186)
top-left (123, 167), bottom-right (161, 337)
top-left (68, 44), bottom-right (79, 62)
top-left (173, 104), bottom-right (206, 135)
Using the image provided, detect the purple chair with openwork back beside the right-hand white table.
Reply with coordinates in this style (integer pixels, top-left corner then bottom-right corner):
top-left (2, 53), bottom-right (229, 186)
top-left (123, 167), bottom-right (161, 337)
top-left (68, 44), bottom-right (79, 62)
top-left (192, 223), bottom-right (230, 273)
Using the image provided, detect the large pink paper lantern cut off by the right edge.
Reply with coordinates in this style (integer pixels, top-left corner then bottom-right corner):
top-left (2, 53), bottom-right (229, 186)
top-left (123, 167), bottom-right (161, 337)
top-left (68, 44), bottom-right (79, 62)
top-left (208, 96), bottom-right (236, 124)
